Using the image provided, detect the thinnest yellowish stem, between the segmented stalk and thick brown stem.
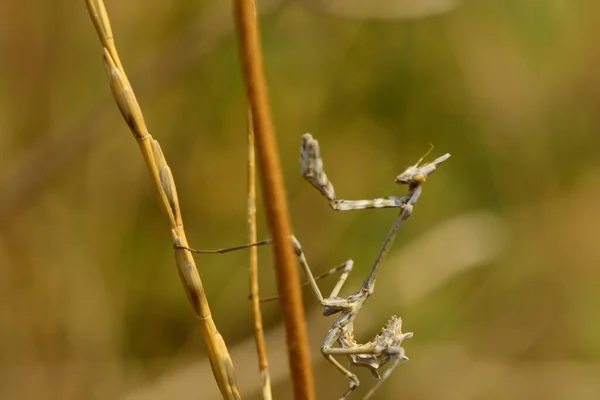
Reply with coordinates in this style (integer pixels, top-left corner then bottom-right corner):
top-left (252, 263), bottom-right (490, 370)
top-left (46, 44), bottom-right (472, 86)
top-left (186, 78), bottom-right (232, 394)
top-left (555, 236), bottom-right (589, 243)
top-left (248, 110), bottom-right (273, 400)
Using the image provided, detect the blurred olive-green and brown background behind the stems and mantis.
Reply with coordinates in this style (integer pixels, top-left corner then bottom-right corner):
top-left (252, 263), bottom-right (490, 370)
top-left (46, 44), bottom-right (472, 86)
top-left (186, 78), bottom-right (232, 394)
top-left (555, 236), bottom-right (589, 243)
top-left (0, 0), bottom-right (600, 400)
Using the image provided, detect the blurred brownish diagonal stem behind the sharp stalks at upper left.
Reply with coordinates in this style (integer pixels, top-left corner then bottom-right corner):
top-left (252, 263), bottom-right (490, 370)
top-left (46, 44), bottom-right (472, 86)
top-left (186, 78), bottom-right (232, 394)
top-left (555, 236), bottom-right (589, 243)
top-left (0, 0), bottom-right (282, 226)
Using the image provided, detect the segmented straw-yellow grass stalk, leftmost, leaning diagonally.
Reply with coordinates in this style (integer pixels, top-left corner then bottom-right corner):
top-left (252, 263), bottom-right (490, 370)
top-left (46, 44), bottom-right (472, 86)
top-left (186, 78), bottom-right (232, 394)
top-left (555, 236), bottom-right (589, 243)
top-left (86, 0), bottom-right (241, 400)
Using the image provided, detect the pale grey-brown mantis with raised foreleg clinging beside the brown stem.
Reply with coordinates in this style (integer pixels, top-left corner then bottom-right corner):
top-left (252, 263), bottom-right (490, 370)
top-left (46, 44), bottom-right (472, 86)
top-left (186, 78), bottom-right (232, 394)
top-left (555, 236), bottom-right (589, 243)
top-left (183, 133), bottom-right (450, 400)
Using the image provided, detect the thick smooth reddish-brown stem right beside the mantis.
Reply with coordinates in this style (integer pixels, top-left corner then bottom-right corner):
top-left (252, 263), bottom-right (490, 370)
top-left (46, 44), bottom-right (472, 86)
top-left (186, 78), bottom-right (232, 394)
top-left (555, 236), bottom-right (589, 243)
top-left (234, 0), bottom-right (315, 400)
